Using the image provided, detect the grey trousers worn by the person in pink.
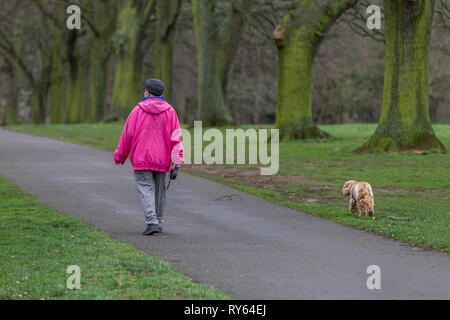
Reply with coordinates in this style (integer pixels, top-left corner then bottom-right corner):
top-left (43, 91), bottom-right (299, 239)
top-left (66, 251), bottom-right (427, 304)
top-left (134, 170), bottom-right (166, 225)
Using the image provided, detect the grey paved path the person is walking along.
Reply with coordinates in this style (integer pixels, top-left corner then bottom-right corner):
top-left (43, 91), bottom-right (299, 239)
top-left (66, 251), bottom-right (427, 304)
top-left (0, 129), bottom-right (450, 299)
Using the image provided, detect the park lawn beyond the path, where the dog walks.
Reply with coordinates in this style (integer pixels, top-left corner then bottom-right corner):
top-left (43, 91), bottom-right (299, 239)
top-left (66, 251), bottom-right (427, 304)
top-left (7, 123), bottom-right (450, 252)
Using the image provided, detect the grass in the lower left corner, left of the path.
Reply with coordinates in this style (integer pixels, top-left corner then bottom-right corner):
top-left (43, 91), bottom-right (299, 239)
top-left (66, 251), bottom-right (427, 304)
top-left (0, 177), bottom-right (228, 300)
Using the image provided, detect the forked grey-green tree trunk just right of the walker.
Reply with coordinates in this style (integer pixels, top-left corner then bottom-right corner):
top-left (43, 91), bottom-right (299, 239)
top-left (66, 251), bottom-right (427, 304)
top-left (192, 0), bottom-right (253, 125)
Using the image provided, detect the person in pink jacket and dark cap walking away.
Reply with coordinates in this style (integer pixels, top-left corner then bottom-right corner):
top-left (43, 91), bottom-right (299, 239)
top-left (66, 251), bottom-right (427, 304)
top-left (114, 79), bottom-right (184, 235)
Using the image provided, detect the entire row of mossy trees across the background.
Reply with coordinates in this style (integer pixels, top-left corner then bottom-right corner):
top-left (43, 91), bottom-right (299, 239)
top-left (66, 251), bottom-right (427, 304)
top-left (0, 0), bottom-right (448, 152)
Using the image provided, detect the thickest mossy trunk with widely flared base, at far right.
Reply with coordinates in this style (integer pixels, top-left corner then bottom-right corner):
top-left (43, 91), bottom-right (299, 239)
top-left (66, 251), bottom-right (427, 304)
top-left (356, 0), bottom-right (445, 152)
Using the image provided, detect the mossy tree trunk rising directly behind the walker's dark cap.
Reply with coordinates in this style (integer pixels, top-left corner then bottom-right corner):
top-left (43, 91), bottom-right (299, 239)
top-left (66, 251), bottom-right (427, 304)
top-left (154, 0), bottom-right (182, 101)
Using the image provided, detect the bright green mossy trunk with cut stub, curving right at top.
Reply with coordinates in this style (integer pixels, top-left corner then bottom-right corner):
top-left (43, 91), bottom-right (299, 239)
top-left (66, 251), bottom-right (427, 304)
top-left (273, 0), bottom-right (356, 141)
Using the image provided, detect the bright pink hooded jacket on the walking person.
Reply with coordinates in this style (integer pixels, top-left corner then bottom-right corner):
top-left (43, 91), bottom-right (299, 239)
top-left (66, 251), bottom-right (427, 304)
top-left (114, 97), bottom-right (184, 172)
